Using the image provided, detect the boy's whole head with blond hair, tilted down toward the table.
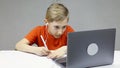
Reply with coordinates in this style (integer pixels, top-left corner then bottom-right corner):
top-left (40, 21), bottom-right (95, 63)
top-left (44, 3), bottom-right (69, 38)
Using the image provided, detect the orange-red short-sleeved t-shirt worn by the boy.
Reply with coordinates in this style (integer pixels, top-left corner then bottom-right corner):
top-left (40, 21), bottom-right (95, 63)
top-left (25, 25), bottom-right (74, 50)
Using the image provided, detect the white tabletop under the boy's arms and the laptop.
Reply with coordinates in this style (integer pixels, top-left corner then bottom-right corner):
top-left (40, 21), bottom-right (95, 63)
top-left (0, 50), bottom-right (120, 68)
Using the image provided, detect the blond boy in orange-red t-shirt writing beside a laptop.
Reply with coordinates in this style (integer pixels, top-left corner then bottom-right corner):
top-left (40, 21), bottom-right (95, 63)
top-left (16, 3), bottom-right (74, 59)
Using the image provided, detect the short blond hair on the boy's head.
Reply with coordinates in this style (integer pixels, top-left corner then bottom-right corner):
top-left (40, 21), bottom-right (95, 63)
top-left (46, 3), bottom-right (69, 22)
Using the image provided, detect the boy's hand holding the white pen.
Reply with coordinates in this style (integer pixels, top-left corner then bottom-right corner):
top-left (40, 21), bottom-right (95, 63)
top-left (33, 47), bottom-right (50, 56)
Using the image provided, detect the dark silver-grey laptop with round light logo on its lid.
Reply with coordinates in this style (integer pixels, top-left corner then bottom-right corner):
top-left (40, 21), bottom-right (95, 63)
top-left (66, 28), bottom-right (116, 68)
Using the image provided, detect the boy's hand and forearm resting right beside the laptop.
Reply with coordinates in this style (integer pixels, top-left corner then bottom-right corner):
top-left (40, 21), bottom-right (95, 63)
top-left (47, 46), bottom-right (67, 59)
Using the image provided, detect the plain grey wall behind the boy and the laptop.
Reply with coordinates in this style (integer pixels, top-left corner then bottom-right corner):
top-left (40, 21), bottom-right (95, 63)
top-left (0, 0), bottom-right (120, 50)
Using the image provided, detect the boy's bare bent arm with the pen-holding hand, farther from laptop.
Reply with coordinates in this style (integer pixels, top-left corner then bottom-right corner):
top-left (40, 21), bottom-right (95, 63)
top-left (15, 38), bottom-right (49, 55)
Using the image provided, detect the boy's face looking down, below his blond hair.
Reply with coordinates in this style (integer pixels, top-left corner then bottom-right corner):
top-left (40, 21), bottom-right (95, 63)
top-left (48, 18), bottom-right (68, 38)
